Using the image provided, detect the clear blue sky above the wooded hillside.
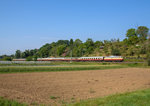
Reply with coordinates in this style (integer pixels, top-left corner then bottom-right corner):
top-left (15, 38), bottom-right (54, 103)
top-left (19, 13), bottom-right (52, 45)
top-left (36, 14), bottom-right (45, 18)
top-left (0, 0), bottom-right (150, 55)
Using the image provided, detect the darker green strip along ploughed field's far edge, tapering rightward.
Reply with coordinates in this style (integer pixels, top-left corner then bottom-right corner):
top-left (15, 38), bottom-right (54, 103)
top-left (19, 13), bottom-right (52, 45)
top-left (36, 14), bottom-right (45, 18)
top-left (0, 65), bottom-right (127, 73)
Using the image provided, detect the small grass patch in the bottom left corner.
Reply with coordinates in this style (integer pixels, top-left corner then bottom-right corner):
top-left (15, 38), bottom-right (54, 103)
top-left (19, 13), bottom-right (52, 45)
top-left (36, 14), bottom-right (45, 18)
top-left (0, 97), bottom-right (27, 106)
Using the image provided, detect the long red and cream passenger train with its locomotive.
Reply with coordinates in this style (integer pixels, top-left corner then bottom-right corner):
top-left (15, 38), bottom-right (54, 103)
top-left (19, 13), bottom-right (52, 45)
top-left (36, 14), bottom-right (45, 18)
top-left (13, 56), bottom-right (124, 62)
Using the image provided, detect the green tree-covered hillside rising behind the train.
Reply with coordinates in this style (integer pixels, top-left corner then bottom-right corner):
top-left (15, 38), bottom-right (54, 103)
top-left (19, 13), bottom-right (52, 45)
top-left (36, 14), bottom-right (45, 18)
top-left (0, 26), bottom-right (150, 60)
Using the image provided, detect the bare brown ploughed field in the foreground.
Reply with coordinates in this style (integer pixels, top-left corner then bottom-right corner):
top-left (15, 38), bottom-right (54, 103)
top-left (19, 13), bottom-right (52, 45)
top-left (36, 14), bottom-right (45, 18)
top-left (0, 68), bottom-right (150, 105)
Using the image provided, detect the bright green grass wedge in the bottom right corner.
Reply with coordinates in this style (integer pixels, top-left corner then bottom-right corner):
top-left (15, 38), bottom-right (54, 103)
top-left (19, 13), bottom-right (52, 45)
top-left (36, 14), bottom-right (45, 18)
top-left (66, 89), bottom-right (150, 106)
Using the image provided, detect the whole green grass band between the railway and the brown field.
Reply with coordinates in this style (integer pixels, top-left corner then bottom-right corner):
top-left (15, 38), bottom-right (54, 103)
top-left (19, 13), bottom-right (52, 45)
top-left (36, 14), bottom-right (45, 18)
top-left (0, 62), bottom-right (150, 73)
